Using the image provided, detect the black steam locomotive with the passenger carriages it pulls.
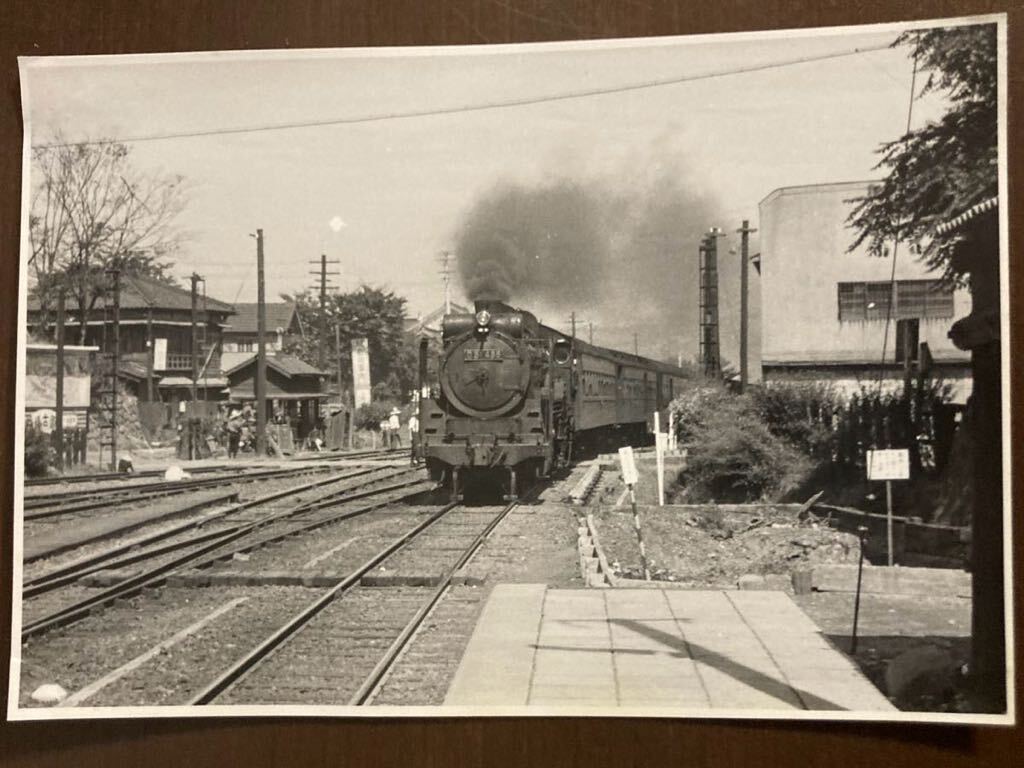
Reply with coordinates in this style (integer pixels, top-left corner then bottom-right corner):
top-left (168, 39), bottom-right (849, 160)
top-left (419, 301), bottom-right (684, 500)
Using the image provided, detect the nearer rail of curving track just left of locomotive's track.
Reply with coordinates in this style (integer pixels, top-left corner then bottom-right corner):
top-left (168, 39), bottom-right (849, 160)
top-left (22, 479), bottom-right (436, 642)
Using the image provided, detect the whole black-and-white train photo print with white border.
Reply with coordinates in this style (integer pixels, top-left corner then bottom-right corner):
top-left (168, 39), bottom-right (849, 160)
top-left (8, 15), bottom-right (1015, 724)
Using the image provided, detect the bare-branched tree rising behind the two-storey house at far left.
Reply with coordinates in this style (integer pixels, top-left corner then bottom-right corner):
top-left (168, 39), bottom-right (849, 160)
top-left (29, 140), bottom-right (184, 343)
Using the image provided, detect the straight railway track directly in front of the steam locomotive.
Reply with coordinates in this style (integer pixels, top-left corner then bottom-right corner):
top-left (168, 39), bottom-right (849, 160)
top-left (189, 502), bottom-right (519, 706)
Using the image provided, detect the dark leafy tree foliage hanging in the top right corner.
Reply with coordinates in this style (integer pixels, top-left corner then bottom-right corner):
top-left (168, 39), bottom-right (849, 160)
top-left (849, 24), bottom-right (998, 279)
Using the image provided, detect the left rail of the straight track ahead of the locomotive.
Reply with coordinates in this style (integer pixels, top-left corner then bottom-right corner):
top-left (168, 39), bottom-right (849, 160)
top-left (188, 502), bottom-right (457, 706)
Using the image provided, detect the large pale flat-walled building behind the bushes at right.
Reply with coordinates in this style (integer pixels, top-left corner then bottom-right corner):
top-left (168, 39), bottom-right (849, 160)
top-left (752, 181), bottom-right (971, 402)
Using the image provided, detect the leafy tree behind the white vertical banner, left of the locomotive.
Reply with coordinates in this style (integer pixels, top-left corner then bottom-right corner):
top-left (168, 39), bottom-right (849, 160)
top-left (282, 286), bottom-right (417, 400)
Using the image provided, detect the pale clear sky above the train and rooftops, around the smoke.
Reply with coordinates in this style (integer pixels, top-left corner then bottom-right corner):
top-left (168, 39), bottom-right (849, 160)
top-left (23, 20), bottom-right (944, 358)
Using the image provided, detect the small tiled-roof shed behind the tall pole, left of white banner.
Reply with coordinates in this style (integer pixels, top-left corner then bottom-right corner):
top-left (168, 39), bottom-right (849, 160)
top-left (226, 353), bottom-right (332, 441)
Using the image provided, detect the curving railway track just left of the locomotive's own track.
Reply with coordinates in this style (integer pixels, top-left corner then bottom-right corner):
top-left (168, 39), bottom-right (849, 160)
top-left (22, 470), bottom-right (434, 642)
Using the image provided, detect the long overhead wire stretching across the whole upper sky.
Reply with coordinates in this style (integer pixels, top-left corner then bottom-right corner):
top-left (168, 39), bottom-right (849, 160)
top-left (33, 43), bottom-right (892, 150)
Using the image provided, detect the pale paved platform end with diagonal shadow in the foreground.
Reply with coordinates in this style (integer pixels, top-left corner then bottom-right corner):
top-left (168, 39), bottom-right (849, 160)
top-left (444, 585), bottom-right (895, 714)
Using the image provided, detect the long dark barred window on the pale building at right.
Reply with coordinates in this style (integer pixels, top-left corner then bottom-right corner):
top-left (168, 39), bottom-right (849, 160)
top-left (839, 280), bottom-right (953, 321)
